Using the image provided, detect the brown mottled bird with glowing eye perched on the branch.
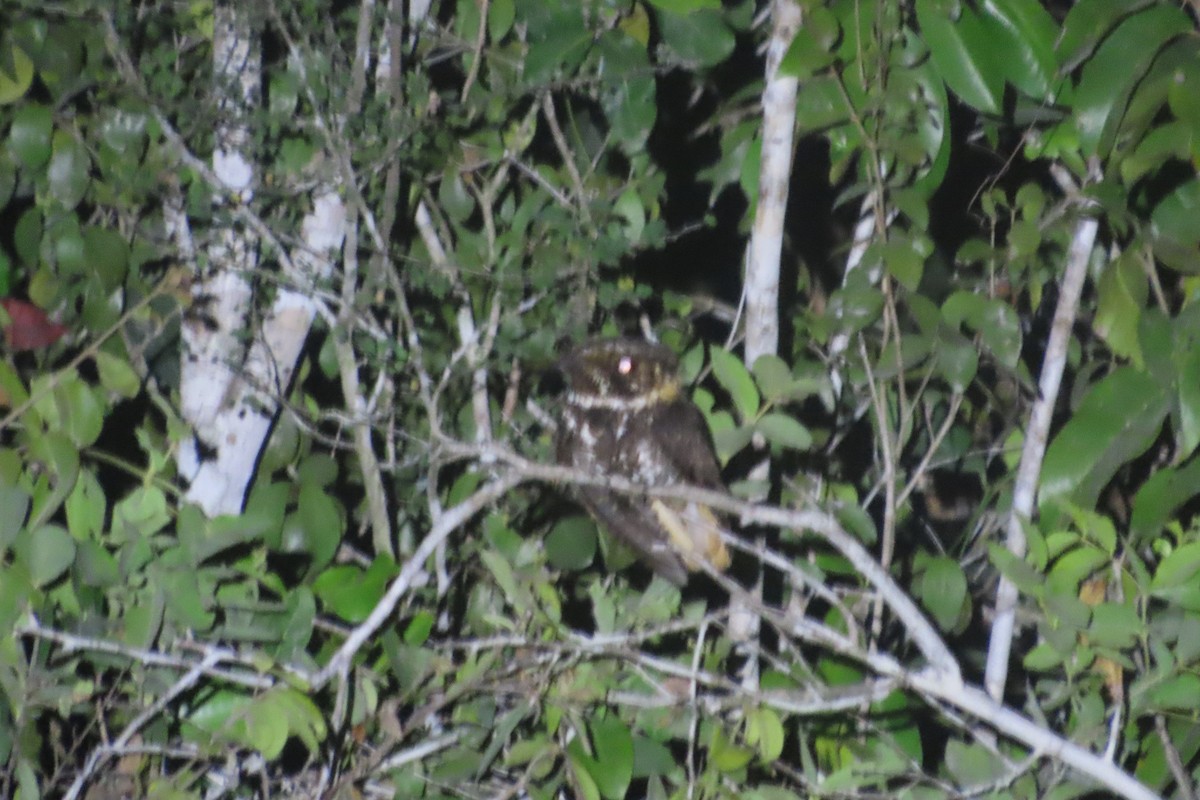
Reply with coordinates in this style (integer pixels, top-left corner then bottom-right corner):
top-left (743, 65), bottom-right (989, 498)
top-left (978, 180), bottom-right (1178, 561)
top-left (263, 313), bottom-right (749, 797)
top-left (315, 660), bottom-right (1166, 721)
top-left (557, 338), bottom-right (730, 585)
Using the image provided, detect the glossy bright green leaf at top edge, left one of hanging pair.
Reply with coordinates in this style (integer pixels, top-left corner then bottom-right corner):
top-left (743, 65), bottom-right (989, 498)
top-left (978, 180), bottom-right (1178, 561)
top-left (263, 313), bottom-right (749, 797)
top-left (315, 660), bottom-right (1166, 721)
top-left (917, 0), bottom-right (1004, 114)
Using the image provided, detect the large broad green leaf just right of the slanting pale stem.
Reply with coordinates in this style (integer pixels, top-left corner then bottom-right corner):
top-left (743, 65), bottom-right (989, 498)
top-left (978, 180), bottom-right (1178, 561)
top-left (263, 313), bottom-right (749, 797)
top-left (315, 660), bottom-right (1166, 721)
top-left (1038, 367), bottom-right (1171, 509)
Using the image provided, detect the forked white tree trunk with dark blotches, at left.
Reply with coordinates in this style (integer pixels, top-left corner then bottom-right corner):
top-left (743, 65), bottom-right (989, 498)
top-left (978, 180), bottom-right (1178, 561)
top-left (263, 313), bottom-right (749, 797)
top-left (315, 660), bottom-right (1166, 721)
top-left (174, 4), bottom-right (346, 516)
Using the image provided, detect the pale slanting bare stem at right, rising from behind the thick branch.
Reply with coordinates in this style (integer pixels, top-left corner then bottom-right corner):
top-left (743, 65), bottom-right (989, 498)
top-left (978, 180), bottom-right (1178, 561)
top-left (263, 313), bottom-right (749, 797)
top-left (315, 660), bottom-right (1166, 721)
top-left (984, 199), bottom-right (1099, 700)
